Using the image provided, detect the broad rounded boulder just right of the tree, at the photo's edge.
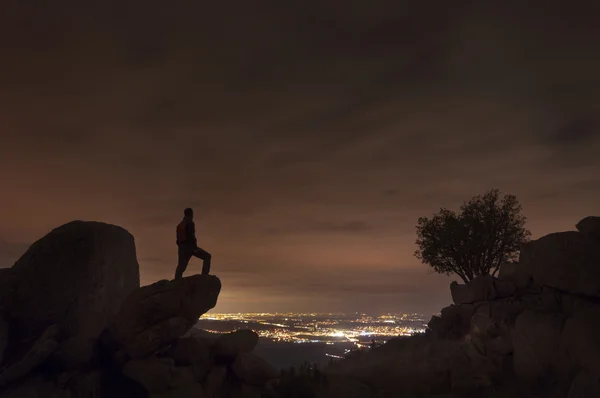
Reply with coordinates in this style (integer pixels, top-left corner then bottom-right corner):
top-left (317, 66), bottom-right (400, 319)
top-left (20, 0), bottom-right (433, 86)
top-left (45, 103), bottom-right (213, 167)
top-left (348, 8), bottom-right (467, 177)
top-left (519, 231), bottom-right (600, 297)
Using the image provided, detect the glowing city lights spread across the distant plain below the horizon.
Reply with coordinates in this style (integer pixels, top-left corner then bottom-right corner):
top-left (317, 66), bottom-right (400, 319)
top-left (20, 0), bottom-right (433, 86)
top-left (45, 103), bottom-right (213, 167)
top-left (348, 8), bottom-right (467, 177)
top-left (196, 313), bottom-right (431, 368)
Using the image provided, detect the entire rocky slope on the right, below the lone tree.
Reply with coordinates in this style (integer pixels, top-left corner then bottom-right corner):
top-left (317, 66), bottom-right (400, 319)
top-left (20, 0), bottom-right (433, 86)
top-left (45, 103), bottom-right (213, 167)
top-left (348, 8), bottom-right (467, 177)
top-left (329, 217), bottom-right (600, 398)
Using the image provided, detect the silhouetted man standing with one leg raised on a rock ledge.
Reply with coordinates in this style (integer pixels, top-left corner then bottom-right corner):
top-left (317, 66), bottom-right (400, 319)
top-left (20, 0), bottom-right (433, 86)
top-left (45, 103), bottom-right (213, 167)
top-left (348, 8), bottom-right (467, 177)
top-left (175, 208), bottom-right (211, 279)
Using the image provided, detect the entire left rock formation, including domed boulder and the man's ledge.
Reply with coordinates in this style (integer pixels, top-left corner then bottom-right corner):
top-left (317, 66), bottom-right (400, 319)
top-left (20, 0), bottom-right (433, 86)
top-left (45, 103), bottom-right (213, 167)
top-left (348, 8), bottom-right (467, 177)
top-left (0, 221), bottom-right (278, 398)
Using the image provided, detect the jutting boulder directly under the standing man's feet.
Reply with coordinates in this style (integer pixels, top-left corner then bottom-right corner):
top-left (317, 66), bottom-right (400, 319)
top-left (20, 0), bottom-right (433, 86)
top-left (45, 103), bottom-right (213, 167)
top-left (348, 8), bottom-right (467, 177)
top-left (110, 275), bottom-right (221, 358)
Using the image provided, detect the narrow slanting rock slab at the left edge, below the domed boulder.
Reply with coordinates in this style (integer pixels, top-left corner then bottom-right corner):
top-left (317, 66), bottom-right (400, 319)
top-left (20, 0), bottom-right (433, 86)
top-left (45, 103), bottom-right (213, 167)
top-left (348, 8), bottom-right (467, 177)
top-left (0, 325), bottom-right (58, 387)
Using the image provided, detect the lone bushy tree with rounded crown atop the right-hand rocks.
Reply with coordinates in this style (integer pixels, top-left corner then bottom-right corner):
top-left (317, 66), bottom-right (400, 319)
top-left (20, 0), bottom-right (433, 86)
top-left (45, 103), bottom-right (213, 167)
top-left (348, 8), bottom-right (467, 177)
top-left (415, 189), bottom-right (531, 283)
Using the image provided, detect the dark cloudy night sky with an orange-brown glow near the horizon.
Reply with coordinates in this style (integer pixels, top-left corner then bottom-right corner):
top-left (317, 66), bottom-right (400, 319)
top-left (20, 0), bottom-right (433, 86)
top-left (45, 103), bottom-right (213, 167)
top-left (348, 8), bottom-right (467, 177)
top-left (0, 0), bottom-right (600, 312)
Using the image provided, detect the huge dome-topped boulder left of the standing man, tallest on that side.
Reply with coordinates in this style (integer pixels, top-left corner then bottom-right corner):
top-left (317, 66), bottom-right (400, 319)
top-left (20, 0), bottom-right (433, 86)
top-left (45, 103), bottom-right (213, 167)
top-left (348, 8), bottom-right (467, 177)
top-left (4, 221), bottom-right (139, 365)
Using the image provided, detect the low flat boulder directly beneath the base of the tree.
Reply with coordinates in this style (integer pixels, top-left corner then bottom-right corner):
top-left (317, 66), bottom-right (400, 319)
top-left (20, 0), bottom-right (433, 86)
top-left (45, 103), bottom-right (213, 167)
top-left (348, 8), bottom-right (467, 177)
top-left (450, 275), bottom-right (515, 304)
